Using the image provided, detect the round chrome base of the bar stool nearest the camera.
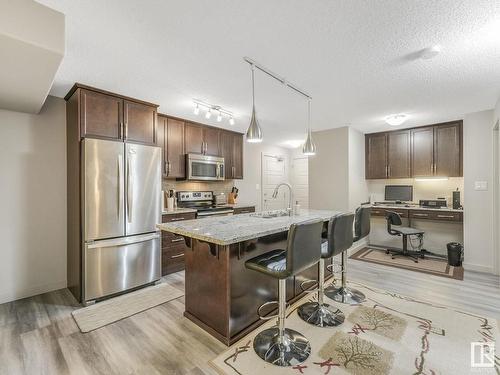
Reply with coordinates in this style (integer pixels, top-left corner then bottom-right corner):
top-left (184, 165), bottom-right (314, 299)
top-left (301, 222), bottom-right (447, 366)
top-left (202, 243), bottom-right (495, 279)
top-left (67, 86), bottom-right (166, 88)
top-left (253, 327), bottom-right (311, 367)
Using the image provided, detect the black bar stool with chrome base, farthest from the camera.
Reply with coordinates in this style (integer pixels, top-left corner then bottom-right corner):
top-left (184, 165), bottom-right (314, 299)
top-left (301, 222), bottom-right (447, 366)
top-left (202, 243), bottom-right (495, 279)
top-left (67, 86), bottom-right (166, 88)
top-left (325, 207), bottom-right (371, 305)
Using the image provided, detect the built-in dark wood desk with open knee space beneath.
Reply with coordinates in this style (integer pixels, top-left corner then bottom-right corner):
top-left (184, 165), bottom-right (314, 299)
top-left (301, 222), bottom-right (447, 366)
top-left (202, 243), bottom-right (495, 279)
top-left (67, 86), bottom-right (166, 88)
top-left (369, 204), bottom-right (464, 255)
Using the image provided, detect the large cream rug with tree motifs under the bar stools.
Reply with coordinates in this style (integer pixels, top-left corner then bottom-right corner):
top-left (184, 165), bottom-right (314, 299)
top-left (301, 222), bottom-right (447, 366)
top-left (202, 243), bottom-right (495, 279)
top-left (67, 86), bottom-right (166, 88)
top-left (211, 283), bottom-right (500, 375)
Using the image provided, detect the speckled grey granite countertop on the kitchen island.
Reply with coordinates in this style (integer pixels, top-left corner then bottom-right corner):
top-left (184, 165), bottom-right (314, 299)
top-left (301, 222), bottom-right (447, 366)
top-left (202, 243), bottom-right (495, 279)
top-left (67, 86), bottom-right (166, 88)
top-left (158, 209), bottom-right (340, 246)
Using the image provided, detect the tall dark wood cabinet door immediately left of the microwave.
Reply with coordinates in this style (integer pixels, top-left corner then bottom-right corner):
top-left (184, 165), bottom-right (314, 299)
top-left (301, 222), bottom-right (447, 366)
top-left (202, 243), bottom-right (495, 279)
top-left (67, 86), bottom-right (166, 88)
top-left (166, 118), bottom-right (186, 178)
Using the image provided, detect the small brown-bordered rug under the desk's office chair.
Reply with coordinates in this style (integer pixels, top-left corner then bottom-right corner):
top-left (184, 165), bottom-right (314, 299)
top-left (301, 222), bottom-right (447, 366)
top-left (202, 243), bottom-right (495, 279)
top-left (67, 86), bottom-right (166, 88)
top-left (349, 247), bottom-right (464, 280)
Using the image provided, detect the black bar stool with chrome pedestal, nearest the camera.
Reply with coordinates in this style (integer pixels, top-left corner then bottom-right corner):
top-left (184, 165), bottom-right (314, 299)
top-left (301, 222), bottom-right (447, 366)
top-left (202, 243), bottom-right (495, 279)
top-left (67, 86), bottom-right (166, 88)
top-left (245, 220), bottom-right (323, 366)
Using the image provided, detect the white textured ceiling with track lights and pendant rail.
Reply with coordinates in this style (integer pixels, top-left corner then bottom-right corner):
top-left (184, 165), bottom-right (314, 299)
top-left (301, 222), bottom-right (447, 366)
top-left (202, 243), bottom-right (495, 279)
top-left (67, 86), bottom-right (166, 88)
top-left (35, 0), bottom-right (500, 143)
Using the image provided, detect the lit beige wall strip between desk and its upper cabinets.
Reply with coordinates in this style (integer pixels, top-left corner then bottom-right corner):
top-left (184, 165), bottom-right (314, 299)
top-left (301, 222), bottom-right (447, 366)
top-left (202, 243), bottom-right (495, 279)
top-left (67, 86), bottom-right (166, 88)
top-left (367, 177), bottom-right (464, 205)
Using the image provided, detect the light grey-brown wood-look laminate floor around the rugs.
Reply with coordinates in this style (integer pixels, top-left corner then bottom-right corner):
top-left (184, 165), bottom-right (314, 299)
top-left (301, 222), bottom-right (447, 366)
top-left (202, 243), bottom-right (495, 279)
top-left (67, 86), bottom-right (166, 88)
top-left (0, 259), bottom-right (500, 375)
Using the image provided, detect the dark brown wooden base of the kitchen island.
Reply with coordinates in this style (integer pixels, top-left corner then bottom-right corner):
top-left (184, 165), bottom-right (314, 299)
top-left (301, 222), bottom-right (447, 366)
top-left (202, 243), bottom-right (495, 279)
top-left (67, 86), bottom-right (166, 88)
top-left (184, 232), bottom-right (318, 345)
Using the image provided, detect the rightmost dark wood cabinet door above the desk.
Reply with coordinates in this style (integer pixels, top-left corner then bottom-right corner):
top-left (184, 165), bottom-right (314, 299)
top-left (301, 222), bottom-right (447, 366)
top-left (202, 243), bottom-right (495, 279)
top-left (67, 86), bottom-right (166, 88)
top-left (434, 122), bottom-right (463, 177)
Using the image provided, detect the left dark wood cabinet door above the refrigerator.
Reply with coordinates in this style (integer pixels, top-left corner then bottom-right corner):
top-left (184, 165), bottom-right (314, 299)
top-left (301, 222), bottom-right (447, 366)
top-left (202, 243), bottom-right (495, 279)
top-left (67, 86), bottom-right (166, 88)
top-left (80, 90), bottom-right (123, 140)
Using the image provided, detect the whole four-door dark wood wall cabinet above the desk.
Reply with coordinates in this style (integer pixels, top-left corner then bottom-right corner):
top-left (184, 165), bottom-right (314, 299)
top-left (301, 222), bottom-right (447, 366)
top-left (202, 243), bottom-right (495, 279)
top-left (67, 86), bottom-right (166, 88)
top-left (365, 121), bottom-right (463, 179)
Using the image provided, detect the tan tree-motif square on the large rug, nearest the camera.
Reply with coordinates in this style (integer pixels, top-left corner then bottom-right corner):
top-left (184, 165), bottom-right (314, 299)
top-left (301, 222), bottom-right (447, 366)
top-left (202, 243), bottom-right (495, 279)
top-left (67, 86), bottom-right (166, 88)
top-left (319, 332), bottom-right (393, 375)
